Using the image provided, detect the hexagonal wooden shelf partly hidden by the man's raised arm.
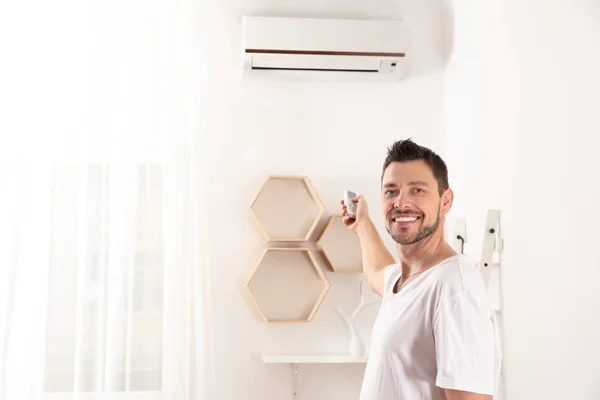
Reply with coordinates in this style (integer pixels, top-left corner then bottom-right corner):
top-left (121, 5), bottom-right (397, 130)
top-left (316, 214), bottom-right (363, 272)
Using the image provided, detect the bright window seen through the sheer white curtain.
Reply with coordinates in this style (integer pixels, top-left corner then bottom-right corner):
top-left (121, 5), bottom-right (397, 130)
top-left (44, 164), bottom-right (166, 395)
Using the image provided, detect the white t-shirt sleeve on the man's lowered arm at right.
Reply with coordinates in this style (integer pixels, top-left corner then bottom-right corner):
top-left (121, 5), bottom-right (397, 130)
top-left (432, 290), bottom-right (497, 395)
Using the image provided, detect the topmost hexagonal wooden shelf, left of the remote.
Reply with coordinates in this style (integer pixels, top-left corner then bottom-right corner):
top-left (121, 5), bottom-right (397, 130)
top-left (250, 176), bottom-right (325, 242)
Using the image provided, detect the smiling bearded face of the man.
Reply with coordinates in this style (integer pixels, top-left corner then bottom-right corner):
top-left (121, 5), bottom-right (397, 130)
top-left (381, 160), bottom-right (452, 245)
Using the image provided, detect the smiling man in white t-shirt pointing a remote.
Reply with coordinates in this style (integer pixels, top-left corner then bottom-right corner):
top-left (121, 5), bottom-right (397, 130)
top-left (342, 140), bottom-right (500, 400)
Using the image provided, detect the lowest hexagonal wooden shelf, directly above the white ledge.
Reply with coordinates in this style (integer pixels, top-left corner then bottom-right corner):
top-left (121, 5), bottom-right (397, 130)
top-left (246, 247), bottom-right (330, 322)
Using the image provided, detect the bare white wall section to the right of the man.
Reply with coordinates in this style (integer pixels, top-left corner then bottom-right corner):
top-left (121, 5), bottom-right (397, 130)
top-left (445, 0), bottom-right (600, 400)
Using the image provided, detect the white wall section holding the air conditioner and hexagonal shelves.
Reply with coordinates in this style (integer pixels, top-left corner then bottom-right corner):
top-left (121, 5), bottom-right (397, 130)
top-left (199, 0), bottom-right (446, 400)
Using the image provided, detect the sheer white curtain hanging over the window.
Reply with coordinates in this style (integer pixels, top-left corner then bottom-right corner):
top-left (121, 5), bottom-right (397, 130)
top-left (0, 0), bottom-right (211, 400)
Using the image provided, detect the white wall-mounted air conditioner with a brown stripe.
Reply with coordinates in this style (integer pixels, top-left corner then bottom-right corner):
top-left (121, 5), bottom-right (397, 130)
top-left (242, 16), bottom-right (406, 80)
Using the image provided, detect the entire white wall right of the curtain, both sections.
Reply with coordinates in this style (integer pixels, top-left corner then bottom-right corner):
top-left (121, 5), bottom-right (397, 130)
top-left (201, 0), bottom-right (600, 400)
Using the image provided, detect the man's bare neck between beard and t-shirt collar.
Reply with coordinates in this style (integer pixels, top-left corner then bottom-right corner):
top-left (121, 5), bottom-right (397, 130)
top-left (396, 231), bottom-right (457, 277)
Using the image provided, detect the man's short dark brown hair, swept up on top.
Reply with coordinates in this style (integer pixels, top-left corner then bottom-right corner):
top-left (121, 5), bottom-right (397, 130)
top-left (381, 139), bottom-right (450, 196)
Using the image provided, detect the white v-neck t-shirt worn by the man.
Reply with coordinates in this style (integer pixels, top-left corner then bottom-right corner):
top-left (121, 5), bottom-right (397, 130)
top-left (360, 255), bottom-right (501, 400)
